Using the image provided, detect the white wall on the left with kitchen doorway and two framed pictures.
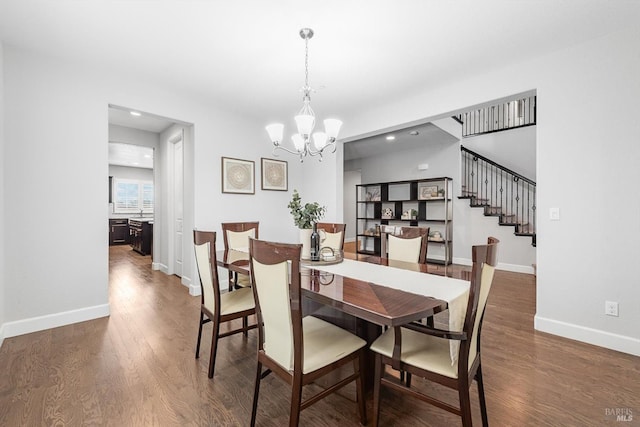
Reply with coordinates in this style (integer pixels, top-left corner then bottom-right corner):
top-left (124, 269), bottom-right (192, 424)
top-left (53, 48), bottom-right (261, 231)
top-left (3, 48), bottom-right (304, 336)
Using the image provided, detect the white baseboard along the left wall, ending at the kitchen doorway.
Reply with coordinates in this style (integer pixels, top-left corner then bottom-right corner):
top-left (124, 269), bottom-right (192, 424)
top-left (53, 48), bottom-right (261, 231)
top-left (3, 304), bottom-right (110, 338)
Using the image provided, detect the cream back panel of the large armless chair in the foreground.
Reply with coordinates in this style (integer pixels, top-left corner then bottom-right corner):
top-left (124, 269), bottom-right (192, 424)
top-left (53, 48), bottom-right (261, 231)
top-left (252, 258), bottom-right (293, 370)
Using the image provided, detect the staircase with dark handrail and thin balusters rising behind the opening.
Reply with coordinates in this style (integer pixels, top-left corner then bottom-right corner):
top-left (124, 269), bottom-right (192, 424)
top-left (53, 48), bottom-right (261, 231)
top-left (458, 147), bottom-right (536, 246)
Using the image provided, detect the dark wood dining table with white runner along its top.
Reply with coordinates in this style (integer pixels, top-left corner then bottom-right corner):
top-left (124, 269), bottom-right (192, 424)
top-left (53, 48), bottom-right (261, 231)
top-left (216, 250), bottom-right (469, 388)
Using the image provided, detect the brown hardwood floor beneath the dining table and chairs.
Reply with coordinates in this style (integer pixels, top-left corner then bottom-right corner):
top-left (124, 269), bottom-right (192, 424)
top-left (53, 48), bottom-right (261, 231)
top-left (0, 246), bottom-right (640, 426)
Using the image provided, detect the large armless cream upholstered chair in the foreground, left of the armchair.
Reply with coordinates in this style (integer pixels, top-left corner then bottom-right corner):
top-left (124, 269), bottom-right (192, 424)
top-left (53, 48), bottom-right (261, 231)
top-left (249, 239), bottom-right (366, 426)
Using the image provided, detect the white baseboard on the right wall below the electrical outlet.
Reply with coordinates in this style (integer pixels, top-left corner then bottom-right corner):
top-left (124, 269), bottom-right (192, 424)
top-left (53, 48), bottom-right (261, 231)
top-left (533, 316), bottom-right (640, 356)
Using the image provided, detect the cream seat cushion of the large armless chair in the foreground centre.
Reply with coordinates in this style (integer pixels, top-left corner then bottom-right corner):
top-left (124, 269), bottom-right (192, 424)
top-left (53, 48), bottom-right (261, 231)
top-left (302, 316), bottom-right (367, 374)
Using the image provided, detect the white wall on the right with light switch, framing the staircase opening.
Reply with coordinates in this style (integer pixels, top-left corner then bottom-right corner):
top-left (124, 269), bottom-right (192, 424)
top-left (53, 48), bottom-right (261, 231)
top-left (338, 28), bottom-right (640, 355)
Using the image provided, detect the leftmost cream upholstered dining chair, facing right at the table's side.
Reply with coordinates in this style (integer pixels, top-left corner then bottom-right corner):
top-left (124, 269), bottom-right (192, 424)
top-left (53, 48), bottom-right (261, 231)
top-left (193, 230), bottom-right (257, 378)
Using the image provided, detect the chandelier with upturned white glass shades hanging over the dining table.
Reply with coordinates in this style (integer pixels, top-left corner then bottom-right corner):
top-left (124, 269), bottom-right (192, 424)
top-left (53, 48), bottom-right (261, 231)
top-left (266, 28), bottom-right (342, 162)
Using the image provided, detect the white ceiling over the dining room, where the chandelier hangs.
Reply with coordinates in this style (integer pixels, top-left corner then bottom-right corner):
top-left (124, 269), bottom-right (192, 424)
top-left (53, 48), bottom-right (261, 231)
top-left (0, 0), bottom-right (640, 159)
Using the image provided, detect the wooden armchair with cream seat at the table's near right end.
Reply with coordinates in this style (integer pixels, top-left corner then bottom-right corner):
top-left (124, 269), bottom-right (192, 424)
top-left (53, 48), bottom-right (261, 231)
top-left (371, 237), bottom-right (498, 427)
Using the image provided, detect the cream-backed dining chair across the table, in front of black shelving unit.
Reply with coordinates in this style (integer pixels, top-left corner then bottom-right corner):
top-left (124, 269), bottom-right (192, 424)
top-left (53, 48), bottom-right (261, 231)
top-left (381, 227), bottom-right (429, 264)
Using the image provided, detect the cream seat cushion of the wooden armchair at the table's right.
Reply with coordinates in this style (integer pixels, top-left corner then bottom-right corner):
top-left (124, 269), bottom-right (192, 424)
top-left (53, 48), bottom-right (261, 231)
top-left (371, 328), bottom-right (458, 378)
